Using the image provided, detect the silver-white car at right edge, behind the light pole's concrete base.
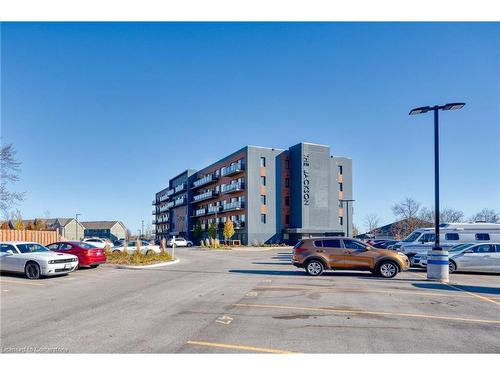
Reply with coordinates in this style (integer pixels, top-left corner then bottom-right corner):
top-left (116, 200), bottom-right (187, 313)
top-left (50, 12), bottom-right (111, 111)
top-left (421, 243), bottom-right (500, 273)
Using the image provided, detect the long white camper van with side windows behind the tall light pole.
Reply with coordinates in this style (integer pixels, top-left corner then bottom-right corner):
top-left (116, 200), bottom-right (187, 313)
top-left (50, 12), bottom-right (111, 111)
top-left (394, 223), bottom-right (500, 260)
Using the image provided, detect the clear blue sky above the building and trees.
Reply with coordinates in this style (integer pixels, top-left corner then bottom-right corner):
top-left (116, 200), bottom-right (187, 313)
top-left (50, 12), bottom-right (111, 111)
top-left (1, 23), bottom-right (500, 232)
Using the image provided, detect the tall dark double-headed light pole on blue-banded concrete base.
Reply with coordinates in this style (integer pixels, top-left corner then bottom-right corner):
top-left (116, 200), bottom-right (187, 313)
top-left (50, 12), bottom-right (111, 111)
top-left (410, 103), bottom-right (465, 282)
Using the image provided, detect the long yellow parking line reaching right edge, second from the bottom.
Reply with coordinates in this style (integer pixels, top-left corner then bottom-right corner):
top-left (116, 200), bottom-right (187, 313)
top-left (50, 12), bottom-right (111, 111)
top-left (233, 303), bottom-right (500, 324)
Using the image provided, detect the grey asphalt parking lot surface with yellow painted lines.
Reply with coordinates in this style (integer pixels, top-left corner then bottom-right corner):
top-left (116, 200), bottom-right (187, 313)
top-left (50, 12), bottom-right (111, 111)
top-left (0, 248), bottom-right (500, 353)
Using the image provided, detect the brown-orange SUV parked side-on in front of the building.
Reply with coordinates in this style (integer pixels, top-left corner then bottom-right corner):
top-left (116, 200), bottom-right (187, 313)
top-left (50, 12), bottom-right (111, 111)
top-left (292, 237), bottom-right (410, 278)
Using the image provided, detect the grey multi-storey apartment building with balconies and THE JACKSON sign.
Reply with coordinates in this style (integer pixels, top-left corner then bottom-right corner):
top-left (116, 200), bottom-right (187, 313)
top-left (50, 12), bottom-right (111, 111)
top-left (153, 143), bottom-right (352, 244)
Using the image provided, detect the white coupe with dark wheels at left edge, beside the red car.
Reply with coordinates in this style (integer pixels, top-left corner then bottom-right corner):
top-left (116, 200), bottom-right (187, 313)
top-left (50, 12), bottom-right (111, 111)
top-left (0, 241), bottom-right (78, 279)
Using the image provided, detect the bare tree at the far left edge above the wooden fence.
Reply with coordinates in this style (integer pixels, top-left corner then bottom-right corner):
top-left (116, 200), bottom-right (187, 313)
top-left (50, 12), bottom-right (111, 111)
top-left (0, 144), bottom-right (24, 214)
